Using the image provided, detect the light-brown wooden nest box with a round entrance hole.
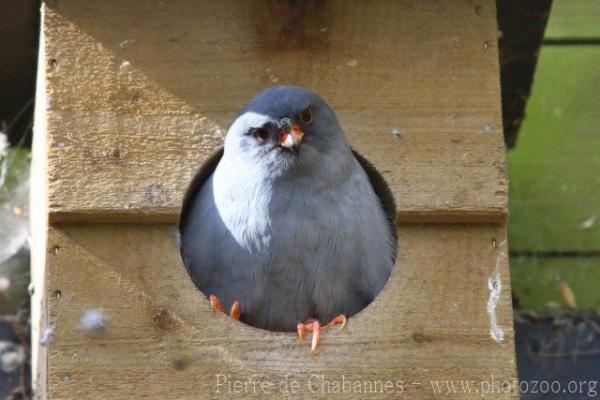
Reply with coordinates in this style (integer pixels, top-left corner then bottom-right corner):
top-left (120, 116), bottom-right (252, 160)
top-left (32, 0), bottom-right (516, 399)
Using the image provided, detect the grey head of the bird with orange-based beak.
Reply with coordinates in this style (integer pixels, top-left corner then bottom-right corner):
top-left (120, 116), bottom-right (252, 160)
top-left (224, 86), bottom-right (351, 178)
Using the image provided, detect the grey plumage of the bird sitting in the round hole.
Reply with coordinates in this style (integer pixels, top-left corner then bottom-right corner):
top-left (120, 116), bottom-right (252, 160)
top-left (181, 87), bottom-right (396, 331)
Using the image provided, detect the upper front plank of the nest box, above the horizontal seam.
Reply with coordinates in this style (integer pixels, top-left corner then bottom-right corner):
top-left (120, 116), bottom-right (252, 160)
top-left (43, 0), bottom-right (507, 222)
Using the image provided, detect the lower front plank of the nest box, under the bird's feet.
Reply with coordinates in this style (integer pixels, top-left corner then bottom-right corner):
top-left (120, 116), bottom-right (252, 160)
top-left (45, 224), bottom-right (516, 399)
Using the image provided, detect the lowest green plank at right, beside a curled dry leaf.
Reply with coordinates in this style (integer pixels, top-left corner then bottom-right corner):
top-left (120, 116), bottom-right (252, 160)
top-left (510, 257), bottom-right (600, 310)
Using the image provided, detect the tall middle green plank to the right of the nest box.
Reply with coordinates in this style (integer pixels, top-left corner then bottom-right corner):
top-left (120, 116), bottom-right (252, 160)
top-left (508, 46), bottom-right (600, 252)
